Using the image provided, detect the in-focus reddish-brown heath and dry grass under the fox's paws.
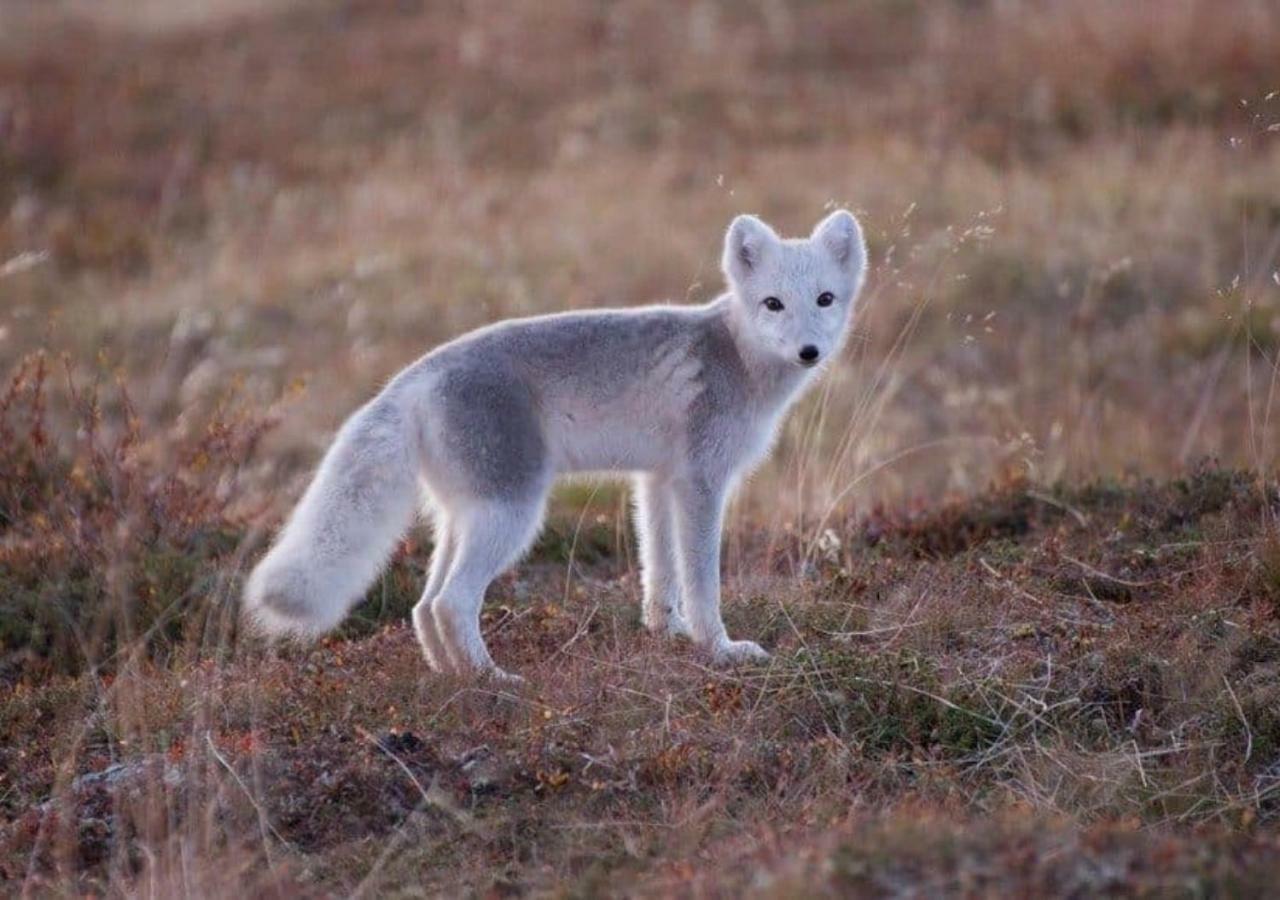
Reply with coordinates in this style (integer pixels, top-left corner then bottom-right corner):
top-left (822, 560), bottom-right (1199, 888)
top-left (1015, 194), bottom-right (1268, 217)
top-left (0, 393), bottom-right (1280, 896)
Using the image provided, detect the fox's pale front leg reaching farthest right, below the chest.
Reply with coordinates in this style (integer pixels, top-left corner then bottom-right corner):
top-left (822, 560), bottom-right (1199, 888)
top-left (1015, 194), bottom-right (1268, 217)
top-left (675, 478), bottom-right (769, 666)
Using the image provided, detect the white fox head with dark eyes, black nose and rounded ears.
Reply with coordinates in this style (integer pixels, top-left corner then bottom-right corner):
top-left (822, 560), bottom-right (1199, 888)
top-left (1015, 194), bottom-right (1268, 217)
top-left (723, 210), bottom-right (867, 366)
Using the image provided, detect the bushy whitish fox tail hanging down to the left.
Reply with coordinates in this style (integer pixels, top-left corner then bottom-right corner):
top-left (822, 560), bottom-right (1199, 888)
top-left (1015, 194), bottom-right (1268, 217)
top-left (244, 397), bottom-right (420, 636)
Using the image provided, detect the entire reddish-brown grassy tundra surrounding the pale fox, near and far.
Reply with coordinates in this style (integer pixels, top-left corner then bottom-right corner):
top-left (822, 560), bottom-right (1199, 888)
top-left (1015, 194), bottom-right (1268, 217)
top-left (0, 0), bottom-right (1280, 896)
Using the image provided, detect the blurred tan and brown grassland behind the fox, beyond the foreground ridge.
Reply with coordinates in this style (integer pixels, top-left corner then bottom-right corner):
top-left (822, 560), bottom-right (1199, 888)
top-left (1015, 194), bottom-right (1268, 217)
top-left (0, 0), bottom-right (1280, 521)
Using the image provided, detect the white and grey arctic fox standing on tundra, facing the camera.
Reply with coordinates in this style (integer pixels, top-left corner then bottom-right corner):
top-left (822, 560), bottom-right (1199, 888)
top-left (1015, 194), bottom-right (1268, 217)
top-left (244, 210), bottom-right (867, 677)
